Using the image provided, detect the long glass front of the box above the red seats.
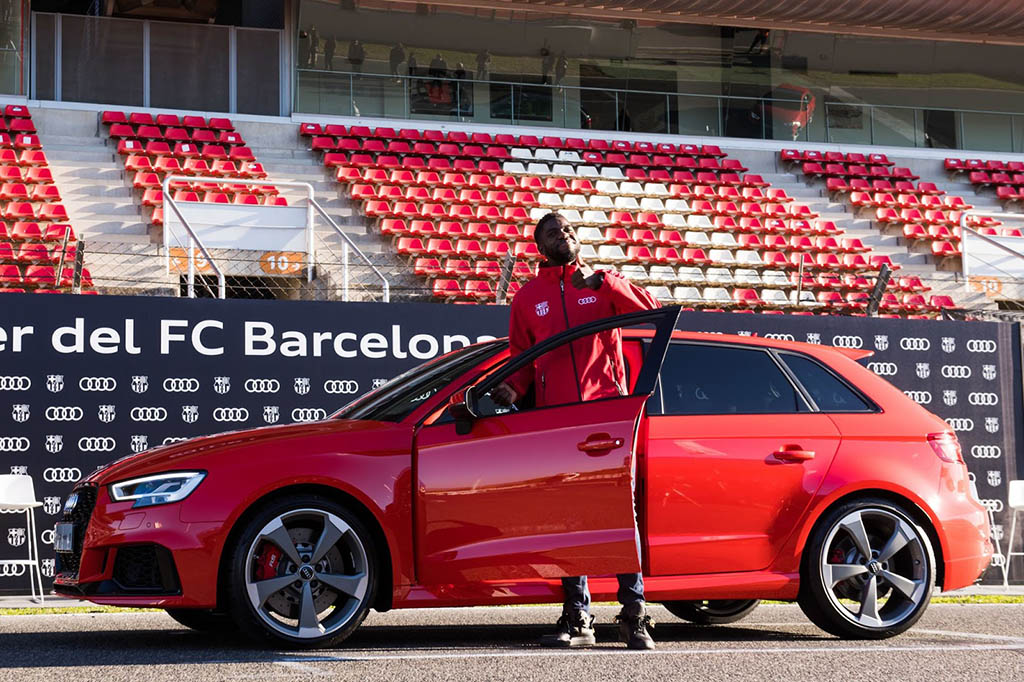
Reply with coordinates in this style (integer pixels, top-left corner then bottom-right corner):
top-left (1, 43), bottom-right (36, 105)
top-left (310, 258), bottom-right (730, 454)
top-left (293, 0), bottom-right (1024, 152)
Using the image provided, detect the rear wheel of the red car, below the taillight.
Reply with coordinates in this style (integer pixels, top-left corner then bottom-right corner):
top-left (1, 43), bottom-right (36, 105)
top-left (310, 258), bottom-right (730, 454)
top-left (798, 499), bottom-right (935, 639)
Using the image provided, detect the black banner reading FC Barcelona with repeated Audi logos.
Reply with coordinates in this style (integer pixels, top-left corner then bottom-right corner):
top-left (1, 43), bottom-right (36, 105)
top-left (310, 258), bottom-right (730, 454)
top-left (0, 295), bottom-right (1022, 593)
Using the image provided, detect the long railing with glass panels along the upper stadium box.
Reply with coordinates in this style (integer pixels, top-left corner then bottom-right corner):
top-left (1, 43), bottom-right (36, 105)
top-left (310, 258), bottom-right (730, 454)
top-left (295, 69), bottom-right (1024, 152)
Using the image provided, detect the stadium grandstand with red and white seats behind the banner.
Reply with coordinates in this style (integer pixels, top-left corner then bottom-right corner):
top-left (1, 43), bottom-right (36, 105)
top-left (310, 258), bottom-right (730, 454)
top-left (6, 0), bottom-right (1024, 317)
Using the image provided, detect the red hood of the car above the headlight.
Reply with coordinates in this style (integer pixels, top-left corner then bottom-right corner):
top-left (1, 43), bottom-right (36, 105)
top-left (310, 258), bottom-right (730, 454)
top-left (85, 419), bottom-right (394, 485)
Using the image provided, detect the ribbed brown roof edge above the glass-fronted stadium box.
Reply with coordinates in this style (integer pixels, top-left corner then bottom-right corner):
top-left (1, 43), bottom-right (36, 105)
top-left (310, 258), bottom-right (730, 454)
top-left (405, 0), bottom-right (1024, 45)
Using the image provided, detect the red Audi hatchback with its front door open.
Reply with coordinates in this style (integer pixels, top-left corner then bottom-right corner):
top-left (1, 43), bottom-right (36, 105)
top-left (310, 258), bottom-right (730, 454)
top-left (55, 308), bottom-right (991, 646)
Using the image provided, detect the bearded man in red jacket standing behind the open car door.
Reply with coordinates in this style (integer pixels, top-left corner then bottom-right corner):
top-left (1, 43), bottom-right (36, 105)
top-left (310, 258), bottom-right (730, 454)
top-left (490, 213), bottom-right (658, 649)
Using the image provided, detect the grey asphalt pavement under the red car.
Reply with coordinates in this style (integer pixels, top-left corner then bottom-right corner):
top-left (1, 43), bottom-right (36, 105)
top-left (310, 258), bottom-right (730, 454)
top-left (0, 604), bottom-right (1024, 682)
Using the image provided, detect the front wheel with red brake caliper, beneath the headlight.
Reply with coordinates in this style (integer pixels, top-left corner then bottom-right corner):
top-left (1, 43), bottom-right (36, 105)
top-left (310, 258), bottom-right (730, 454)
top-left (226, 495), bottom-right (378, 648)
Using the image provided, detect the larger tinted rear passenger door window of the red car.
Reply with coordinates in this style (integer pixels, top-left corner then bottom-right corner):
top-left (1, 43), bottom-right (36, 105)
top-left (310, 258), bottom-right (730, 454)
top-left (660, 343), bottom-right (808, 415)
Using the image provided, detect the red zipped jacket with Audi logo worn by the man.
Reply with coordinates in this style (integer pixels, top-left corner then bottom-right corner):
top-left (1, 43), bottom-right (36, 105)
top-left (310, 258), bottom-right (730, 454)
top-left (508, 263), bottom-right (658, 407)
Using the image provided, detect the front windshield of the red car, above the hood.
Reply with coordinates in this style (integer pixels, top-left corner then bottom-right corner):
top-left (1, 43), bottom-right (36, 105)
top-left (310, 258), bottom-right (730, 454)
top-left (332, 341), bottom-right (508, 422)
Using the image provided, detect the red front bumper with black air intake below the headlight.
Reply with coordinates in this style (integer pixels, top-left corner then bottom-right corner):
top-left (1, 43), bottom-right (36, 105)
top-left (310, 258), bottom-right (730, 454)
top-left (53, 486), bottom-right (222, 608)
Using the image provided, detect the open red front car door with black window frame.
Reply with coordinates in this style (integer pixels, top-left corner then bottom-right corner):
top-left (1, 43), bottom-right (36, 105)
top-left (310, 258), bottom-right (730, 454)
top-left (414, 307), bottom-right (679, 585)
